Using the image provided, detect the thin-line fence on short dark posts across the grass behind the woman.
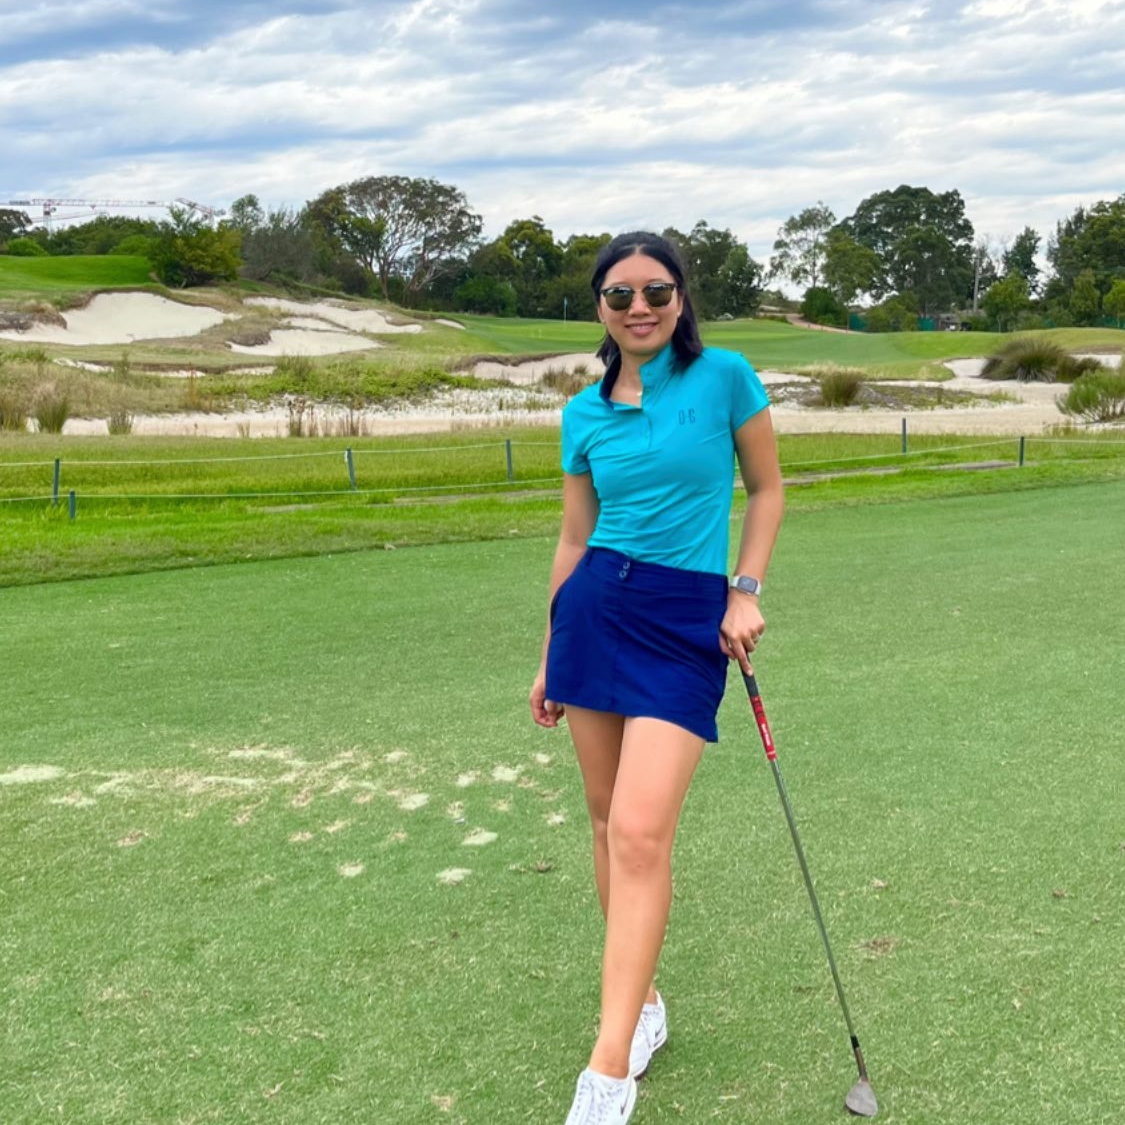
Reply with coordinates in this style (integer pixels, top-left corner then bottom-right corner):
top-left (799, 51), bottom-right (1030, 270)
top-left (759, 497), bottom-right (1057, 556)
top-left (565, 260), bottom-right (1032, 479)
top-left (0, 429), bottom-right (1125, 519)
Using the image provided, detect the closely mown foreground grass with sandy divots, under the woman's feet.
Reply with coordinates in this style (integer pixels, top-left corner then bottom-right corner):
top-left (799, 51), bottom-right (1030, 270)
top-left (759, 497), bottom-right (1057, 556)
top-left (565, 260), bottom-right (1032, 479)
top-left (0, 482), bottom-right (1125, 1125)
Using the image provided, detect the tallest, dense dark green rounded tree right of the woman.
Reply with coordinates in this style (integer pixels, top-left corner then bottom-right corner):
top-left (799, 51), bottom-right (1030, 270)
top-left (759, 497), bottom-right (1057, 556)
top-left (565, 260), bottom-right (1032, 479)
top-left (839, 183), bottom-right (973, 312)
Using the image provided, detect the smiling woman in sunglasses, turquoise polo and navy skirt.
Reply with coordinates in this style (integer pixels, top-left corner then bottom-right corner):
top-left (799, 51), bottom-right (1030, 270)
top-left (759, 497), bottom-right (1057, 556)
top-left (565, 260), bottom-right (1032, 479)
top-left (531, 232), bottom-right (783, 1125)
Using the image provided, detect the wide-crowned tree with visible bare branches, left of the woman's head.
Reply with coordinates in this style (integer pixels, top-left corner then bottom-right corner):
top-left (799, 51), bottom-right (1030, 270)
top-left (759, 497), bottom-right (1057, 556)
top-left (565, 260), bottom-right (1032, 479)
top-left (307, 176), bottom-right (482, 299)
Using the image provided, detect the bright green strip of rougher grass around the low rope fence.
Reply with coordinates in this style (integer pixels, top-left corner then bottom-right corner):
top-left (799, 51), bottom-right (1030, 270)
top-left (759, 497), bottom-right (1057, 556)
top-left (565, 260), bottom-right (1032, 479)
top-left (0, 428), bottom-right (1125, 586)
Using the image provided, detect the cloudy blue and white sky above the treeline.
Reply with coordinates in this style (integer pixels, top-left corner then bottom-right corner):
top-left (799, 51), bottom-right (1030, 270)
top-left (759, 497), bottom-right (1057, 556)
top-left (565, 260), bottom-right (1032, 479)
top-left (0, 0), bottom-right (1125, 259)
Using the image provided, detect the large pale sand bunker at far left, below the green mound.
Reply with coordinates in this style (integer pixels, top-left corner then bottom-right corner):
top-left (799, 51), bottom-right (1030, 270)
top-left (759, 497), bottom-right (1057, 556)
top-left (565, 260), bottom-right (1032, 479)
top-left (0, 293), bottom-right (230, 344)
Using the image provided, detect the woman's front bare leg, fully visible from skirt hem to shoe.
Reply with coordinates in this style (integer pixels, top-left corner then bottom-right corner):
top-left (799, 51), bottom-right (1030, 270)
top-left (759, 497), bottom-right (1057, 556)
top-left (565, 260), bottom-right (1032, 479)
top-left (590, 718), bottom-right (703, 1078)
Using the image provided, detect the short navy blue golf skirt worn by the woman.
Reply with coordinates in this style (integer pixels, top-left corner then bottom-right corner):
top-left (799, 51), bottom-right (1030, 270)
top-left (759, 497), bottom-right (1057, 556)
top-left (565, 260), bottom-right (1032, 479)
top-left (547, 547), bottom-right (728, 743)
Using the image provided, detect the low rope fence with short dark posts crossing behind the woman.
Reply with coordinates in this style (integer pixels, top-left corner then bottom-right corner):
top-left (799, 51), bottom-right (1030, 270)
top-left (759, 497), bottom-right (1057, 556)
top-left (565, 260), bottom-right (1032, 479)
top-left (0, 427), bottom-right (1125, 520)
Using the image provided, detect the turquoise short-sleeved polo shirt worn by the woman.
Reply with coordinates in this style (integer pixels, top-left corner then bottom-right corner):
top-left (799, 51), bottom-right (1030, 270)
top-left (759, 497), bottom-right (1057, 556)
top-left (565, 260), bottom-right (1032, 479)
top-left (563, 343), bottom-right (770, 574)
